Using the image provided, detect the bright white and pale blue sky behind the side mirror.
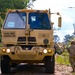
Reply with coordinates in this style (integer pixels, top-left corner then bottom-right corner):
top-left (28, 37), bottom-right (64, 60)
top-left (30, 0), bottom-right (75, 41)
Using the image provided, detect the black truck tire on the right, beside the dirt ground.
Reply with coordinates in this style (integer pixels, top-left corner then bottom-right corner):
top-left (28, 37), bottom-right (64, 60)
top-left (45, 56), bottom-right (55, 73)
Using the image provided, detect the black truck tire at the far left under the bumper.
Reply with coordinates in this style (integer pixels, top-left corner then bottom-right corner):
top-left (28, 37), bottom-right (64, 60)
top-left (1, 56), bottom-right (11, 74)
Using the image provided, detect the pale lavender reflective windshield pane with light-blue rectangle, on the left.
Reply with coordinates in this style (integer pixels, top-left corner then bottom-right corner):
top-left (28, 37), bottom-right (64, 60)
top-left (4, 12), bottom-right (26, 29)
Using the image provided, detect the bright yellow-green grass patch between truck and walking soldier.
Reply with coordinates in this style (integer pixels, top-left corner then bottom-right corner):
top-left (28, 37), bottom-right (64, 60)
top-left (55, 52), bottom-right (70, 65)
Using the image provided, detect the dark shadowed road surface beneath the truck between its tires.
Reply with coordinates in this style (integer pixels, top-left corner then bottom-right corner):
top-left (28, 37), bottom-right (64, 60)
top-left (0, 65), bottom-right (55, 75)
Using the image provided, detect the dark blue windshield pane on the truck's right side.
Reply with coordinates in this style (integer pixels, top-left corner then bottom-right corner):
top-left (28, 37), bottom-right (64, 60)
top-left (29, 12), bottom-right (51, 30)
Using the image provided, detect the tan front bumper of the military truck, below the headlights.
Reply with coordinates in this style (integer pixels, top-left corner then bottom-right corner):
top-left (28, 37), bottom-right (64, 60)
top-left (0, 47), bottom-right (55, 60)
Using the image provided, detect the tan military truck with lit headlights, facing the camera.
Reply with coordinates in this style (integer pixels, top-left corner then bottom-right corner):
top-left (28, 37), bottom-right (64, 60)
top-left (0, 9), bottom-right (61, 74)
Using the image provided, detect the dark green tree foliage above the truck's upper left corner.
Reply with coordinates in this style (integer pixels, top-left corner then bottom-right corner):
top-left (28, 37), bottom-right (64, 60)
top-left (0, 0), bottom-right (29, 19)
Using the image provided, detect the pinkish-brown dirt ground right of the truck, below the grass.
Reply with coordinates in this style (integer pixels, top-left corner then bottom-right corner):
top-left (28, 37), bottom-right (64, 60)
top-left (55, 64), bottom-right (75, 75)
